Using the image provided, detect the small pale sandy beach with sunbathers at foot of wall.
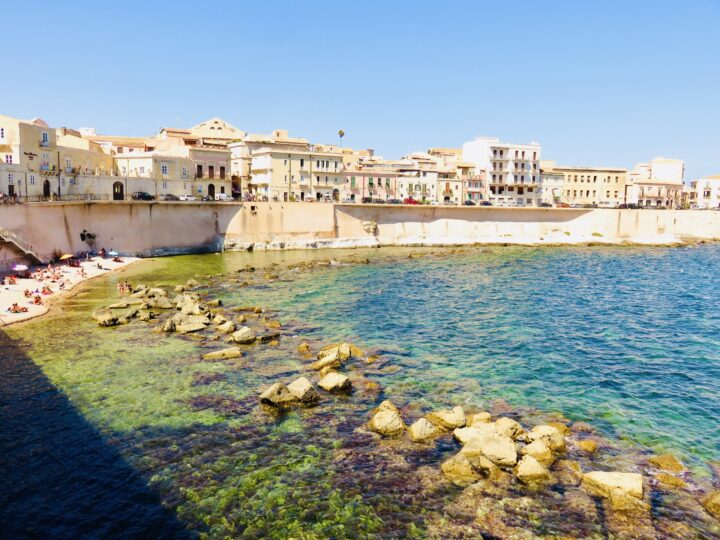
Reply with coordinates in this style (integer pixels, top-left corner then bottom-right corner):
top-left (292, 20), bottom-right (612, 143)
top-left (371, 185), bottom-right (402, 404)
top-left (0, 257), bottom-right (139, 327)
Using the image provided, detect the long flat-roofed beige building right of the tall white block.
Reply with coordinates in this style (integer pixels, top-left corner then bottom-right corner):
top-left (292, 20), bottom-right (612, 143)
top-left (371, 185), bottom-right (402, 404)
top-left (540, 160), bottom-right (627, 208)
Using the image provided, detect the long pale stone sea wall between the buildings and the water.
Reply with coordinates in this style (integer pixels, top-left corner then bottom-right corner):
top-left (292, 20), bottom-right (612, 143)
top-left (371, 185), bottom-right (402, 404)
top-left (0, 202), bottom-right (720, 265)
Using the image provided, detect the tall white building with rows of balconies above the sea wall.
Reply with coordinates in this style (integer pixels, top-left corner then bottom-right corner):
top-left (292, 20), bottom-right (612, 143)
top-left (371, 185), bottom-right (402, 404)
top-left (462, 137), bottom-right (541, 206)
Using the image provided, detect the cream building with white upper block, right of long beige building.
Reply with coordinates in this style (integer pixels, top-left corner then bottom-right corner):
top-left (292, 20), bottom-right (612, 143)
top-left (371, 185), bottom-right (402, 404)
top-left (626, 157), bottom-right (685, 208)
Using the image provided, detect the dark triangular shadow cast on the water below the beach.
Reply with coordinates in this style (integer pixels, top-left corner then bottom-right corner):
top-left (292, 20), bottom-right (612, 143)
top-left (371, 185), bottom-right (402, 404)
top-left (0, 331), bottom-right (190, 538)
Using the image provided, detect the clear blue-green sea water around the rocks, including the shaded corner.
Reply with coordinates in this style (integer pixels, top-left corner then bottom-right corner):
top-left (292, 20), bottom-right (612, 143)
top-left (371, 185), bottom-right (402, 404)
top-left (0, 245), bottom-right (720, 538)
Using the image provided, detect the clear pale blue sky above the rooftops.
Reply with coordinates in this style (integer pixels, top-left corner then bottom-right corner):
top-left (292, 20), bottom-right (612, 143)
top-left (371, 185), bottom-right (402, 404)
top-left (0, 0), bottom-right (720, 180)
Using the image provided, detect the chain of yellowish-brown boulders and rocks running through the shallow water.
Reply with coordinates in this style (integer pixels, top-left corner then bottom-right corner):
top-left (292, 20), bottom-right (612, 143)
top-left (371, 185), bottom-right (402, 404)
top-left (88, 252), bottom-right (720, 538)
